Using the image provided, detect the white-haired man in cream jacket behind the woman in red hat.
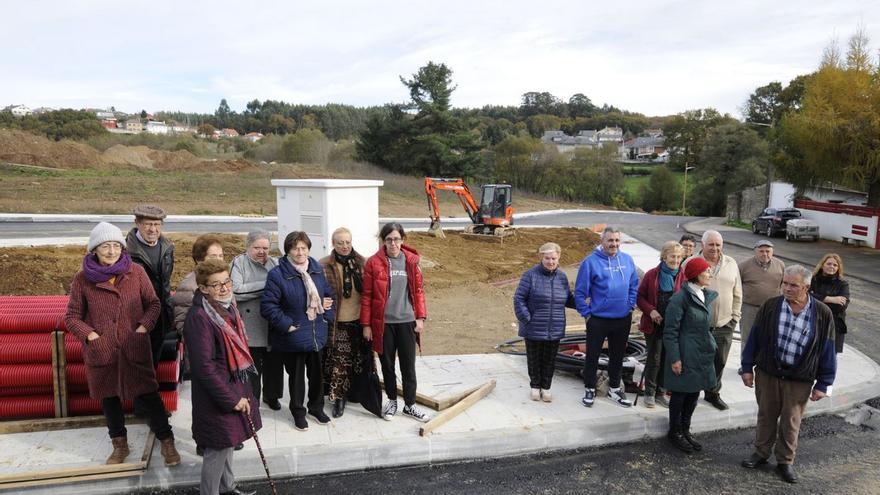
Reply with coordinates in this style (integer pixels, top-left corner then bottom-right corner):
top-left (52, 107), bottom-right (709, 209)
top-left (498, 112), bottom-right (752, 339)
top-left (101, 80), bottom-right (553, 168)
top-left (700, 230), bottom-right (742, 411)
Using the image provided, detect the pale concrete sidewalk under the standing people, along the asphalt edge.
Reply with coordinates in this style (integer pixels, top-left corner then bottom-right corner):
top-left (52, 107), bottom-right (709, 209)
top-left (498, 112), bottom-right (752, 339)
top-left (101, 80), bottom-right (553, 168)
top-left (8, 345), bottom-right (880, 495)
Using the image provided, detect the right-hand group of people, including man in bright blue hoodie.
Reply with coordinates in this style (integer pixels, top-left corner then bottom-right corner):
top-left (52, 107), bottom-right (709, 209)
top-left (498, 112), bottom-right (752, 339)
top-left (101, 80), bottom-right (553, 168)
top-left (514, 227), bottom-right (850, 483)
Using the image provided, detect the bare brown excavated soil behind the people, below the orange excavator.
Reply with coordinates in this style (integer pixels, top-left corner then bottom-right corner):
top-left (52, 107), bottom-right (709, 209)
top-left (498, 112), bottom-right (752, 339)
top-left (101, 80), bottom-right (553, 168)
top-left (0, 228), bottom-right (598, 354)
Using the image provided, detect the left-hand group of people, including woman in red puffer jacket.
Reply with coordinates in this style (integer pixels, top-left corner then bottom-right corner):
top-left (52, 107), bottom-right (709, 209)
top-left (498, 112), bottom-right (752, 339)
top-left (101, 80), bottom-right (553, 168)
top-left (65, 205), bottom-right (429, 494)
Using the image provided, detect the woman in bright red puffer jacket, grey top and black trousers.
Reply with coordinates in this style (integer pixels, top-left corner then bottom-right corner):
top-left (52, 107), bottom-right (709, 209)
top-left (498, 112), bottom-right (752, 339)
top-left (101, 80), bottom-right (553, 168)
top-left (361, 223), bottom-right (429, 422)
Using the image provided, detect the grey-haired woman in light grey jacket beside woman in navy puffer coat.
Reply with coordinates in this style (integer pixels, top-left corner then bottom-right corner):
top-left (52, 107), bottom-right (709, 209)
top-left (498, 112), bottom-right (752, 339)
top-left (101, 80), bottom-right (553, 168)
top-left (229, 230), bottom-right (284, 411)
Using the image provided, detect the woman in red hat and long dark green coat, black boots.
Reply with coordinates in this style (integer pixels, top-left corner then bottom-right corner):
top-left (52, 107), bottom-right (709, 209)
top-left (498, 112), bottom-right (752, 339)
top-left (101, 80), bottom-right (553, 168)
top-left (663, 258), bottom-right (718, 453)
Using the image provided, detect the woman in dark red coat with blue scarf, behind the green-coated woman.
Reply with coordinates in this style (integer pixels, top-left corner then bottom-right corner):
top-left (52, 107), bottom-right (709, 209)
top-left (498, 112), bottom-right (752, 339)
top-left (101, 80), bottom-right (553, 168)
top-left (636, 241), bottom-right (685, 407)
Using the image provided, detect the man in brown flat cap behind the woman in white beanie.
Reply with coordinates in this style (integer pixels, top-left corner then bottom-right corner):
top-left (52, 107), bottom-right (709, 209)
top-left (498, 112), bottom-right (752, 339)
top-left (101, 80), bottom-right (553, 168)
top-left (125, 205), bottom-right (174, 367)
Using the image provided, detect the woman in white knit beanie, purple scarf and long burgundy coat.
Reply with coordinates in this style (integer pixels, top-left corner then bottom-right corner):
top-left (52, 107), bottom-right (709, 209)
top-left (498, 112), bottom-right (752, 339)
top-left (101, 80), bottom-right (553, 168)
top-left (64, 222), bottom-right (180, 466)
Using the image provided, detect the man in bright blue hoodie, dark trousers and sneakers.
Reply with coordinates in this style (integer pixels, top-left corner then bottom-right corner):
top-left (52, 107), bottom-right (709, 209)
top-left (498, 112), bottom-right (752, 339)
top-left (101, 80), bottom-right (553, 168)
top-left (574, 227), bottom-right (639, 407)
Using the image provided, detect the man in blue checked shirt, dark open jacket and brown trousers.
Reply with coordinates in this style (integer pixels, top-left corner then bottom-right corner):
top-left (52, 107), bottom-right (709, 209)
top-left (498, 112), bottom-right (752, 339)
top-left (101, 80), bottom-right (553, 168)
top-left (739, 265), bottom-right (837, 483)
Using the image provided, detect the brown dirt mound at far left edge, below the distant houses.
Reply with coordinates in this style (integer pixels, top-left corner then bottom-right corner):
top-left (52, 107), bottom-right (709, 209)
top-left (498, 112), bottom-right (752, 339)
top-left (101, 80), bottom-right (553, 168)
top-left (0, 129), bottom-right (107, 168)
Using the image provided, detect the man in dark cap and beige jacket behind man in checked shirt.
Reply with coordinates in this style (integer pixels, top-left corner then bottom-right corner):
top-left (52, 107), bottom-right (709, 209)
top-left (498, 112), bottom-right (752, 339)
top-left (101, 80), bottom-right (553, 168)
top-left (739, 239), bottom-right (785, 347)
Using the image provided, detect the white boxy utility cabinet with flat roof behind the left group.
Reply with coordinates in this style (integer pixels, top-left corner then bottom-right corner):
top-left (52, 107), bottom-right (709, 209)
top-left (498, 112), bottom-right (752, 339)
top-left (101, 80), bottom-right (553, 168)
top-left (272, 179), bottom-right (384, 259)
